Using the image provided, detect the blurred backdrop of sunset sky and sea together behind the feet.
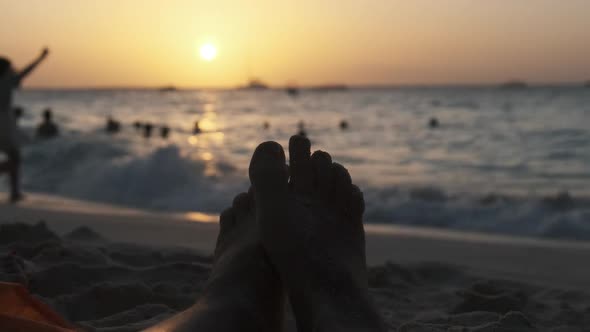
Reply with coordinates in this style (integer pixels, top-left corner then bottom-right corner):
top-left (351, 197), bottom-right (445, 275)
top-left (0, 0), bottom-right (590, 240)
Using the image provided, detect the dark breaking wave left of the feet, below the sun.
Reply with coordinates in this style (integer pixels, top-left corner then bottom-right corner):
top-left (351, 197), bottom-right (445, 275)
top-left (23, 135), bottom-right (248, 212)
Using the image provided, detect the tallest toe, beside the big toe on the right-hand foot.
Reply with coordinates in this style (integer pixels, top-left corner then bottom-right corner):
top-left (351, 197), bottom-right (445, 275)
top-left (289, 135), bottom-right (313, 194)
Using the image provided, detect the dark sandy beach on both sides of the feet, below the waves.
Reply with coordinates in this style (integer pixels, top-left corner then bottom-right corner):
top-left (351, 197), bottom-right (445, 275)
top-left (0, 194), bottom-right (590, 331)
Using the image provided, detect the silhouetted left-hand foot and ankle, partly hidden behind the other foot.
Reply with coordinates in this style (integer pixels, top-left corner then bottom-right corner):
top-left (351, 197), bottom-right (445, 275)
top-left (148, 193), bottom-right (284, 332)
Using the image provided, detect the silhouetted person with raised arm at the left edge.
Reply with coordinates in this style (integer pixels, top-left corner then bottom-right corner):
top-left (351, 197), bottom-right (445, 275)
top-left (0, 48), bottom-right (49, 203)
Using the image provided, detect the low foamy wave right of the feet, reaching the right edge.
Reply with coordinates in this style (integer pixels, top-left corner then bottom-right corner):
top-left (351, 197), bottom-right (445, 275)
top-left (365, 187), bottom-right (590, 240)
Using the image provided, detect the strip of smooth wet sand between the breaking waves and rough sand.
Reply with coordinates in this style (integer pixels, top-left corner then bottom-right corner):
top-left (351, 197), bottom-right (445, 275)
top-left (0, 193), bottom-right (590, 291)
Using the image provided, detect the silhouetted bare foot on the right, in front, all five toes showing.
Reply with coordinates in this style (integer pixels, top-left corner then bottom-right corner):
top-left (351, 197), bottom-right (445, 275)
top-left (250, 136), bottom-right (382, 331)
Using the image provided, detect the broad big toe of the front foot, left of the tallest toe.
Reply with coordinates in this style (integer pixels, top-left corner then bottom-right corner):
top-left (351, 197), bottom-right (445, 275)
top-left (249, 141), bottom-right (288, 193)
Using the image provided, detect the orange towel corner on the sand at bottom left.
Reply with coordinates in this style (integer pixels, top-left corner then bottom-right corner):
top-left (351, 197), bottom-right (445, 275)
top-left (0, 282), bottom-right (75, 332)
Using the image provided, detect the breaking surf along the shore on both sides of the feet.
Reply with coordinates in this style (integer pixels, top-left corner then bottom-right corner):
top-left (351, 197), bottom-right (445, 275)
top-left (4, 133), bottom-right (590, 240)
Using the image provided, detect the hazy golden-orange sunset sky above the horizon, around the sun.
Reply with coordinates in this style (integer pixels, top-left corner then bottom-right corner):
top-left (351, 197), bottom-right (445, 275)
top-left (0, 0), bottom-right (590, 87)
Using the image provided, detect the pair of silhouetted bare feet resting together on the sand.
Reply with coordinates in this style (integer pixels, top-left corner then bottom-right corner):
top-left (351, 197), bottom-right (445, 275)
top-left (149, 136), bottom-right (384, 332)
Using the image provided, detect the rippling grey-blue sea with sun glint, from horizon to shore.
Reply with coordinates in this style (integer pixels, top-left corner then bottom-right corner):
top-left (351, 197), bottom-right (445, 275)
top-left (2, 87), bottom-right (590, 240)
